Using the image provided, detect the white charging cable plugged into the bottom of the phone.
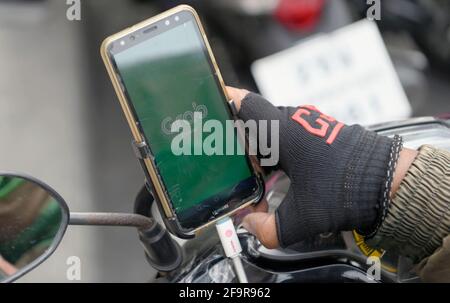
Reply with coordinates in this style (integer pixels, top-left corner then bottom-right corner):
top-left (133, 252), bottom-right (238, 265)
top-left (216, 217), bottom-right (248, 283)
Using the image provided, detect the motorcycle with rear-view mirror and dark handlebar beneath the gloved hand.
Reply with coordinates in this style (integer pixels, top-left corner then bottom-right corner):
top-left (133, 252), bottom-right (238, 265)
top-left (0, 116), bottom-right (450, 283)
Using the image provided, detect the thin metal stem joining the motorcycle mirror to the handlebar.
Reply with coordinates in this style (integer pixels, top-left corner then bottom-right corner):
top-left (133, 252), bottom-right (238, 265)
top-left (69, 212), bottom-right (155, 230)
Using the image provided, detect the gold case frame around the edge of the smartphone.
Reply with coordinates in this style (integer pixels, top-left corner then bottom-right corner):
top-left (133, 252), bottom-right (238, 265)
top-left (100, 5), bottom-right (263, 238)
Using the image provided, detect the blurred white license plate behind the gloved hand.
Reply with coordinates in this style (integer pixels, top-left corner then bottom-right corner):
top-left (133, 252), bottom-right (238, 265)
top-left (252, 20), bottom-right (411, 124)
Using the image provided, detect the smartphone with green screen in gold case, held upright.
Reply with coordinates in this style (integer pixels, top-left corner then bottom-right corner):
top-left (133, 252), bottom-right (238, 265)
top-left (101, 5), bottom-right (264, 238)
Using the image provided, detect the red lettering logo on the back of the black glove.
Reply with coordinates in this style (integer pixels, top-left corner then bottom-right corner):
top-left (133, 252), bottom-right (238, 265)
top-left (292, 105), bottom-right (344, 145)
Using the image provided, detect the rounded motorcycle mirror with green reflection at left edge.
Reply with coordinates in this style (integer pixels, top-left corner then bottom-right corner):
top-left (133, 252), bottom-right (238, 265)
top-left (0, 173), bottom-right (69, 282)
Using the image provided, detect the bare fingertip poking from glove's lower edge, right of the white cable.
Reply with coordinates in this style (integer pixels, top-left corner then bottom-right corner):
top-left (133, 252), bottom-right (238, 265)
top-left (242, 213), bottom-right (279, 248)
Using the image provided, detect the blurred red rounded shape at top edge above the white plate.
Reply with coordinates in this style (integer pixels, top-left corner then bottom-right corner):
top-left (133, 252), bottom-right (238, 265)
top-left (275, 0), bottom-right (325, 31)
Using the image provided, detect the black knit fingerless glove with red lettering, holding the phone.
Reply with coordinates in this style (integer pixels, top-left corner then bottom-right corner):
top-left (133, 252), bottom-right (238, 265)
top-left (239, 93), bottom-right (392, 247)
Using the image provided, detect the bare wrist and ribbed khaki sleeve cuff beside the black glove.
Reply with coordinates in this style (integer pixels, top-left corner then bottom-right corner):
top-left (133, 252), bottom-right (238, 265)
top-left (369, 146), bottom-right (450, 262)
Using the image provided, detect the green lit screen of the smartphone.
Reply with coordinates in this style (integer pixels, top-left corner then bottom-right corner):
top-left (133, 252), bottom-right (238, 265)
top-left (113, 13), bottom-right (258, 228)
